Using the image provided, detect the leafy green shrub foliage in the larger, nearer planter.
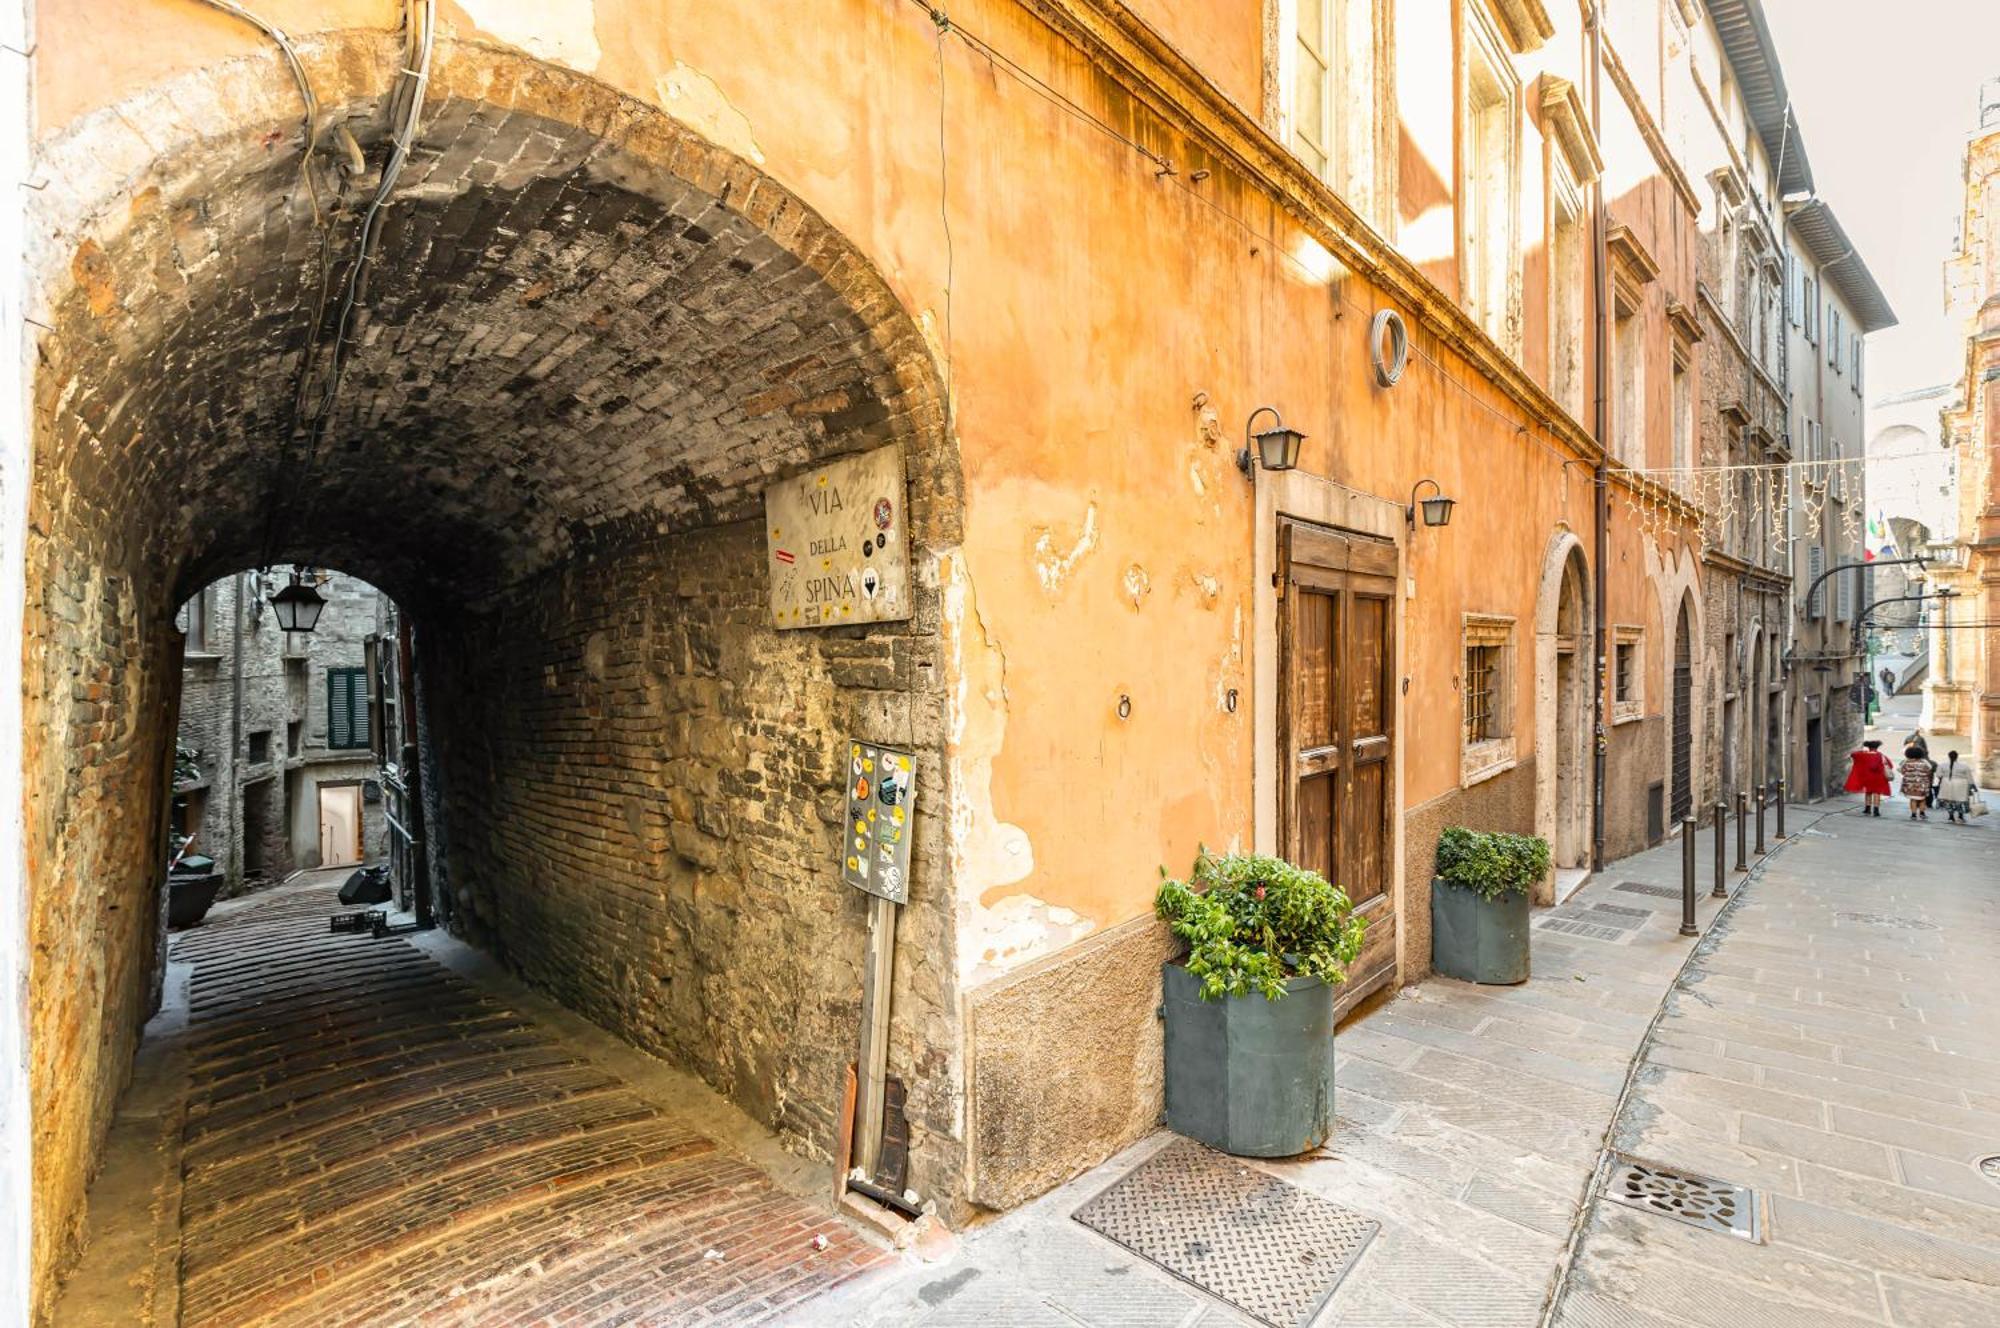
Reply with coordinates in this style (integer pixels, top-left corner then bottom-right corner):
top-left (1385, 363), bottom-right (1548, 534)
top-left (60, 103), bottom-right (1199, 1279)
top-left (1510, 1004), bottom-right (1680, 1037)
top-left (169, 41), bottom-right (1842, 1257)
top-left (1152, 848), bottom-right (1368, 1000)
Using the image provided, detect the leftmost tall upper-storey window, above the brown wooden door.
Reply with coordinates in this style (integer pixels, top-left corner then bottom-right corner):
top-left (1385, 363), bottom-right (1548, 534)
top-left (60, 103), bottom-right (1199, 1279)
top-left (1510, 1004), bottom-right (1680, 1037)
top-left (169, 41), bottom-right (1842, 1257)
top-left (1278, 0), bottom-right (1382, 222)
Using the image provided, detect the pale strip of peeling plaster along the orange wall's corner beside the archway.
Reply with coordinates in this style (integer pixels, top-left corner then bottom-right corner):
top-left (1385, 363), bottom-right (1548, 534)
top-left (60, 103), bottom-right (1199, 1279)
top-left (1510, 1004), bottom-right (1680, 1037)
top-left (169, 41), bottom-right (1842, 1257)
top-left (938, 552), bottom-right (1056, 986)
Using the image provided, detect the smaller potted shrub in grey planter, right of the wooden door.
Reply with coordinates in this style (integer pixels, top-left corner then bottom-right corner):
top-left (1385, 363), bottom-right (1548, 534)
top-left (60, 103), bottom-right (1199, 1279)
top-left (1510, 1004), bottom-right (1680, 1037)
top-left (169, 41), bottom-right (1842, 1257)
top-left (1430, 826), bottom-right (1548, 984)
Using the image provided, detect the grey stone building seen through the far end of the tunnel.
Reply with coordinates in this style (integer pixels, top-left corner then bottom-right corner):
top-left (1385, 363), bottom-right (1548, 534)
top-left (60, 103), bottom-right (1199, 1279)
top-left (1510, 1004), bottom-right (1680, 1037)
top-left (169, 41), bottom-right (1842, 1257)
top-left (170, 572), bottom-right (386, 894)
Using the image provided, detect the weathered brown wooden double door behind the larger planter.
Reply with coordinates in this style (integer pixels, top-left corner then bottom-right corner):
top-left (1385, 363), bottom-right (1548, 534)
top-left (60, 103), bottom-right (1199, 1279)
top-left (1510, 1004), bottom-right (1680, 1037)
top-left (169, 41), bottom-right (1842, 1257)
top-left (1278, 520), bottom-right (1396, 1010)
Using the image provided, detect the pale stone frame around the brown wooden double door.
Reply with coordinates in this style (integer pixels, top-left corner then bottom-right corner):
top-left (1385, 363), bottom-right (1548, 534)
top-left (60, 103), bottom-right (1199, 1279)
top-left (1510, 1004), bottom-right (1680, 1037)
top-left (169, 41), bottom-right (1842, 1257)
top-left (1250, 470), bottom-right (1428, 1012)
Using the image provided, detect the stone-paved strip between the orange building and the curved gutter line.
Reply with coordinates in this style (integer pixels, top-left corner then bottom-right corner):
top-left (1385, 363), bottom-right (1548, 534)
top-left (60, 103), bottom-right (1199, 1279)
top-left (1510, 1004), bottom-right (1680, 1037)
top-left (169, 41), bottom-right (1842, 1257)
top-left (812, 836), bottom-right (1740, 1328)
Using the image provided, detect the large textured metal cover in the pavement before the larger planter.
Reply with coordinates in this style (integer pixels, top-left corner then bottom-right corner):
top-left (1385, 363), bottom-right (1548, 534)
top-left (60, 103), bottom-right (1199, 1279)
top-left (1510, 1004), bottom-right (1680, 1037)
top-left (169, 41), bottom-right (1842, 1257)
top-left (1074, 1140), bottom-right (1380, 1328)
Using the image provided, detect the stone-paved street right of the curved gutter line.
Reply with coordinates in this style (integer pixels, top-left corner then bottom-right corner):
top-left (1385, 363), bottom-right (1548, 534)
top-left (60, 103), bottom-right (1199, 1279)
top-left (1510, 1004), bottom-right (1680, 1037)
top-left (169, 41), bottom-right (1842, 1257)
top-left (1556, 802), bottom-right (2000, 1328)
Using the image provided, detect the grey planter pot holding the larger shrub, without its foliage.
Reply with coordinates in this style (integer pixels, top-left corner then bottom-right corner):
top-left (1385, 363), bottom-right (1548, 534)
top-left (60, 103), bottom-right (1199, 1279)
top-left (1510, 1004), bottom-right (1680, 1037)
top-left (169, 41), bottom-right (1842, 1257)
top-left (1162, 964), bottom-right (1334, 1158)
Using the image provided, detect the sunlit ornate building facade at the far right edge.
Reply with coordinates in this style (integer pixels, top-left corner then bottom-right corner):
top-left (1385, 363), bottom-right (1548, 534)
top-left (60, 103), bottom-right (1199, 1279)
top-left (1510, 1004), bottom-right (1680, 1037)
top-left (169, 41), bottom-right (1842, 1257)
top-left (1924, 78), bottom-right (2000, 788)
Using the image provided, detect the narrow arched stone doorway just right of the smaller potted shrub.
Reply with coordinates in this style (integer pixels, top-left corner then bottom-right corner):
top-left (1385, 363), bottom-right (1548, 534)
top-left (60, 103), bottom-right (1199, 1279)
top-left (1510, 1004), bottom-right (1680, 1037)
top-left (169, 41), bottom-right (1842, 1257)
top-left (1534, 528), bottom-right (1594, 904)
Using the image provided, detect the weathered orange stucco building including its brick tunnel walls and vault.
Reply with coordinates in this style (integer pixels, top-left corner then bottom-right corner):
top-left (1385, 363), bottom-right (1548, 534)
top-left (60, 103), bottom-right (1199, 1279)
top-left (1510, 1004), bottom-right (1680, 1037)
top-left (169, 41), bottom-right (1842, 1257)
top-left (0, 0), bottom-right (1896, 1320)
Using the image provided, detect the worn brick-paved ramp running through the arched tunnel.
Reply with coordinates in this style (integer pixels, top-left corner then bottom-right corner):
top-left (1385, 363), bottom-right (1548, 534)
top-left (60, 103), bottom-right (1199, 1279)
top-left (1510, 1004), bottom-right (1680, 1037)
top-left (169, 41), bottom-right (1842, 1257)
top-left (156, 886), bottom-right (882, 1328)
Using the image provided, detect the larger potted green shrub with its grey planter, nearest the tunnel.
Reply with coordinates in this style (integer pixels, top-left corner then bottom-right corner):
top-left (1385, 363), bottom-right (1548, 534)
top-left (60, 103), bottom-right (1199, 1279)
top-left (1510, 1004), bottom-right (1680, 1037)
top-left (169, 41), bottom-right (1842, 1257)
top-left (1154, 848), bottom-right (1364, 1158)
